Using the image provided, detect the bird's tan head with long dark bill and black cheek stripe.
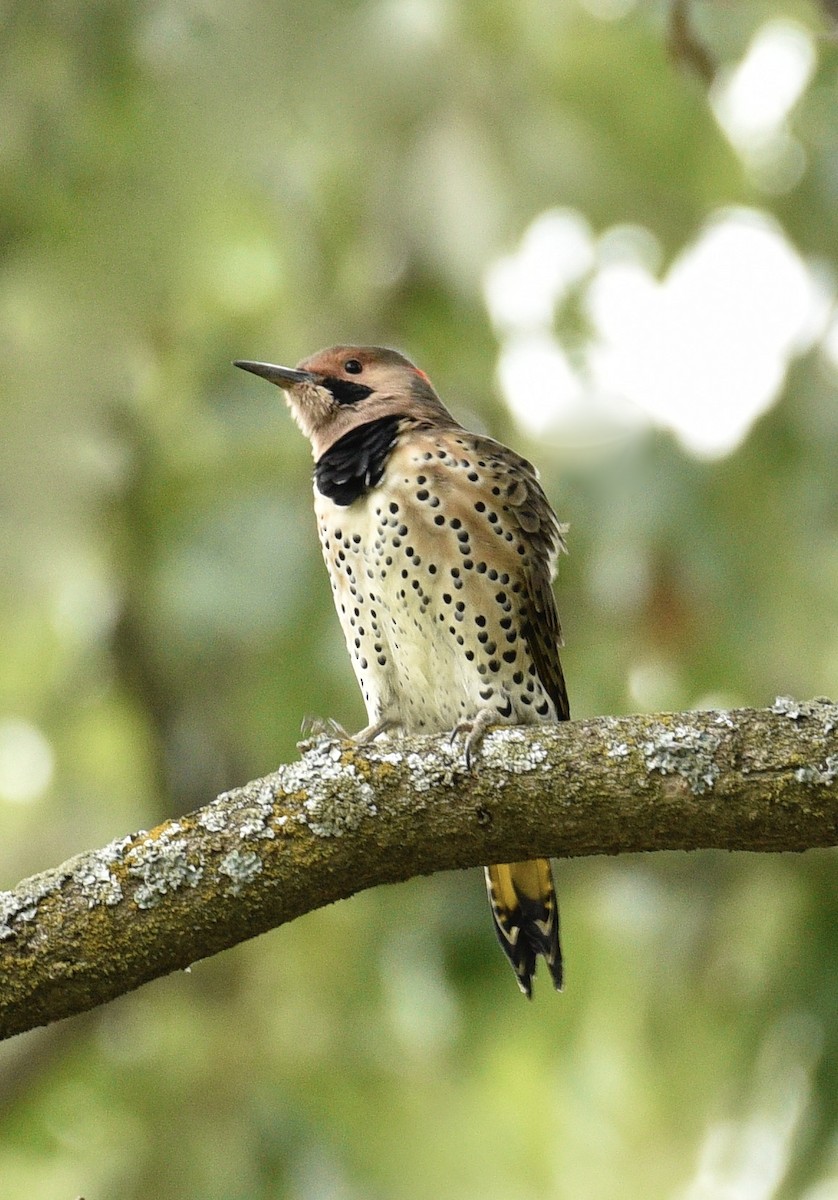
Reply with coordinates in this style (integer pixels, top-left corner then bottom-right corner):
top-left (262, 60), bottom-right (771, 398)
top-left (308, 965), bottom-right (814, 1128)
top-left (235, 346), bottom-right (457, 458)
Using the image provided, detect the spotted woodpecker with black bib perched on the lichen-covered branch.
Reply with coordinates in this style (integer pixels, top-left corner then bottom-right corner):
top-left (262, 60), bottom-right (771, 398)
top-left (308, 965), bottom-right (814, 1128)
top-left (234, 346), bottom-right (570, 997)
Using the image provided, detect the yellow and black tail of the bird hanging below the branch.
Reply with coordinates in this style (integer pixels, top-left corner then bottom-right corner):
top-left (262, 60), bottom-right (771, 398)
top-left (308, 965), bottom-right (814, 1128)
top-left (485, 858), bottom-right (562, 996)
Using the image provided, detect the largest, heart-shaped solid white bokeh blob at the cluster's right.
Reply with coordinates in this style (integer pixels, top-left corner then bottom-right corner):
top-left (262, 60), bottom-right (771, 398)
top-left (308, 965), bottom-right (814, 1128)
top-left (587, 211), bottom-right (826, 456)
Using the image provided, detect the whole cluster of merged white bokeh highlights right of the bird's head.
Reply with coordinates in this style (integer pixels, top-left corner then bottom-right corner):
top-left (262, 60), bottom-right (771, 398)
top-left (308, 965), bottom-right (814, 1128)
top-left (485, 209), bottom-right (834, 457)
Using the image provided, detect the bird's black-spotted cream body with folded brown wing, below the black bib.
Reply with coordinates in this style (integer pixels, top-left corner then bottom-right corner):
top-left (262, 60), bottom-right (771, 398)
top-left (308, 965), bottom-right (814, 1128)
top-left (315, 422), bottom-right (568, 732)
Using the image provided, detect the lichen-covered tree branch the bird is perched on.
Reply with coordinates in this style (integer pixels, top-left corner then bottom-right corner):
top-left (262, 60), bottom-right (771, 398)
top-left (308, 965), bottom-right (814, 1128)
top-left (0, 698), bottom-right (838, 1038)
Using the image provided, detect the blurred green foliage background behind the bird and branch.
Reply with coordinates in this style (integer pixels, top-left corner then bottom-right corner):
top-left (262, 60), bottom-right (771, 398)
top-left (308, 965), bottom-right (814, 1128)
top-left (0, 0), bottom-right (838, 1200)
